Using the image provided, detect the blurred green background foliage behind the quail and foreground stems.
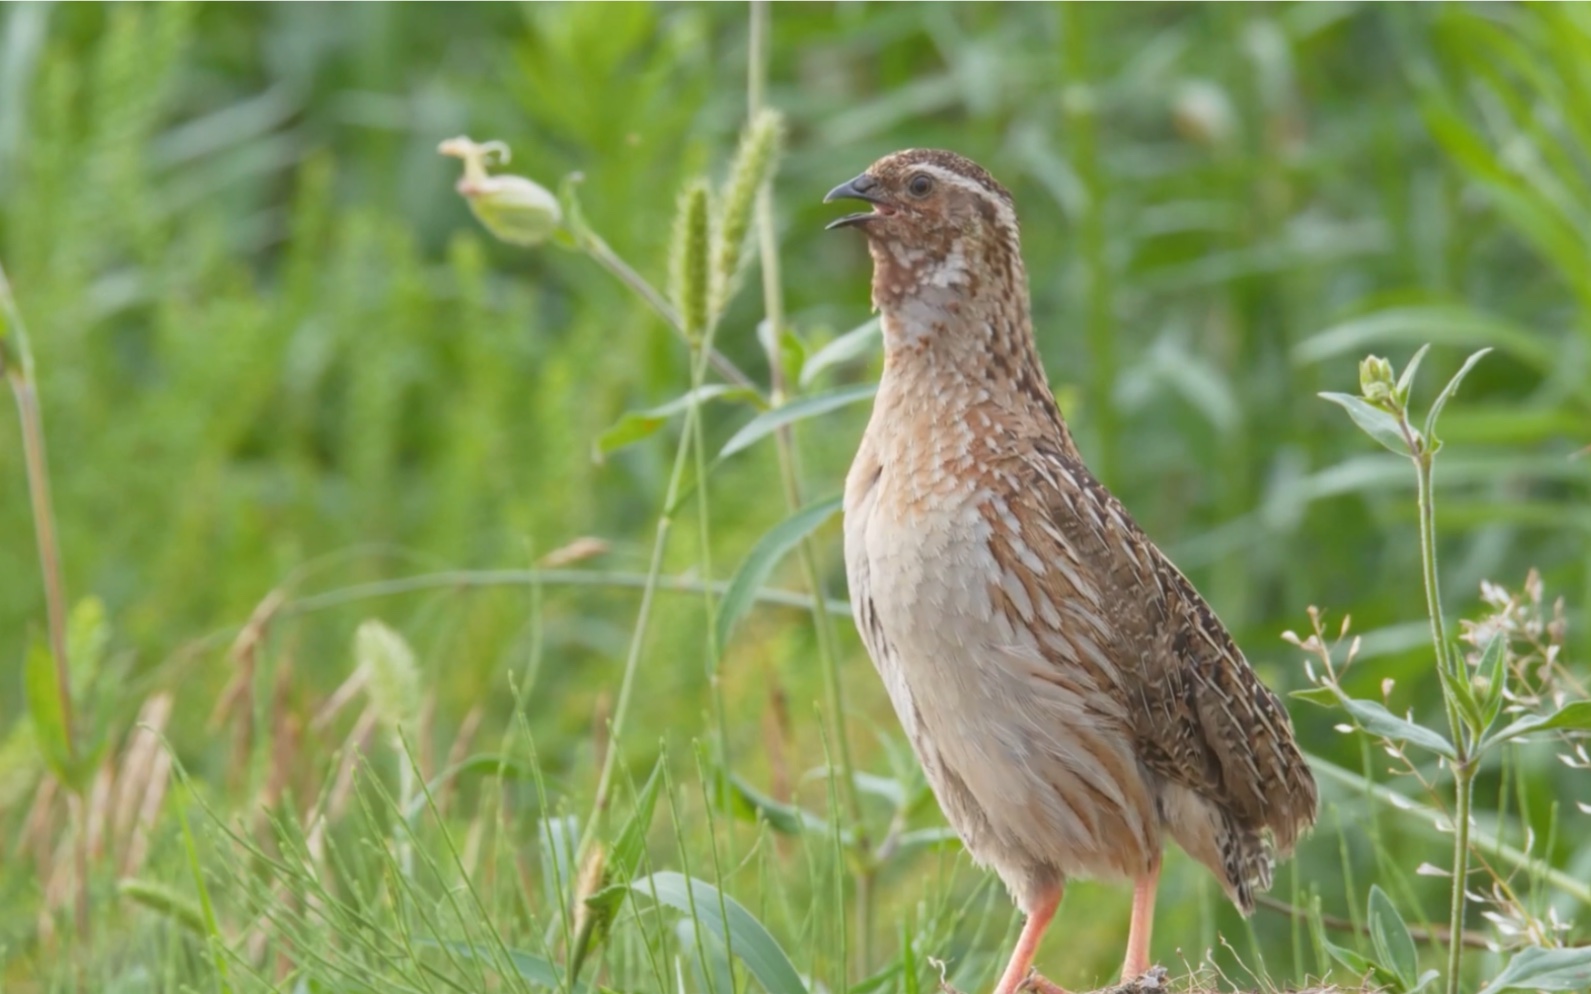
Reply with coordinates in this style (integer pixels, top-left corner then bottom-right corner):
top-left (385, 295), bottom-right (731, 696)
top-left (0, 3), bottom-right (1591, 989)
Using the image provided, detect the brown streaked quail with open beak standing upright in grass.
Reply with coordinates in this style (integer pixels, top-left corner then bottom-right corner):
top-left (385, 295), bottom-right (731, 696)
top-left (824, 149), bottom-right (1317, 994)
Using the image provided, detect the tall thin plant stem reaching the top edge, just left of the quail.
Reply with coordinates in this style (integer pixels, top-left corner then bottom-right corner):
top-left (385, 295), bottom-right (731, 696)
top-left (746, 0), bottom-right (873, 972)
